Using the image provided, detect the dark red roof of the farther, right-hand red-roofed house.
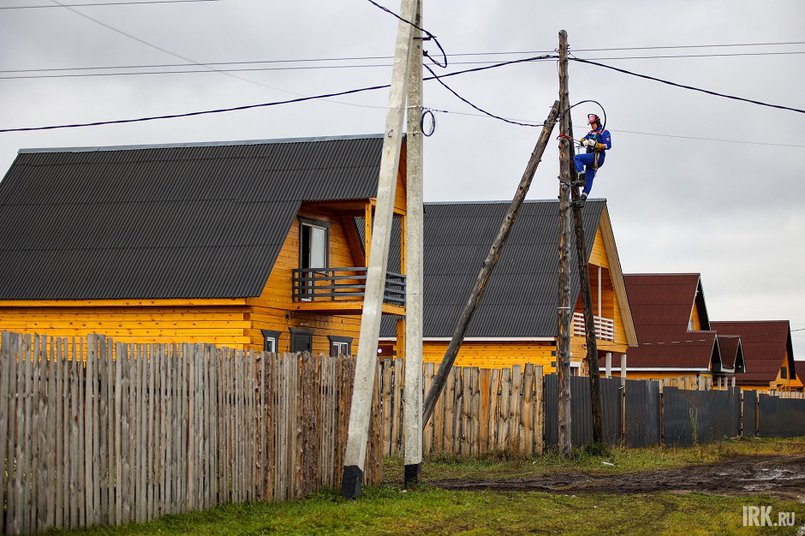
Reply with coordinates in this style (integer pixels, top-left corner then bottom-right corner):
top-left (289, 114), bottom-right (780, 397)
top-left (711, 320), bottom-right (794, 386)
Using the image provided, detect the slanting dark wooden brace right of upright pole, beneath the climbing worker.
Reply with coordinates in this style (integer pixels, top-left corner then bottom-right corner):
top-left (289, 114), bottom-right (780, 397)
top-left (565, 95), bottom-right (604, 444)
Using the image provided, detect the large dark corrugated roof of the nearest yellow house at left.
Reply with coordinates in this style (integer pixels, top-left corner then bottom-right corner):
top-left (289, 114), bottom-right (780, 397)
top-left (0, 135), bottom-right (383, 300)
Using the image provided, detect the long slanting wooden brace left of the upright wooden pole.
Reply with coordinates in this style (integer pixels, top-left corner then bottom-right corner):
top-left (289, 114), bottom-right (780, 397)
top-left (422, 101), bottom-right (559, 426)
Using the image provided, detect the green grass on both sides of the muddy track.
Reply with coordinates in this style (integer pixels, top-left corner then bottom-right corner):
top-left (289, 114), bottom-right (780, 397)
top-left (48, 438), bottom-right (805, 536)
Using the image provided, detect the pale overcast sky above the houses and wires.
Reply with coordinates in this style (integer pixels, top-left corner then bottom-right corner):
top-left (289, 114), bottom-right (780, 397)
top-left (0, 0), bottom-right (805, 359)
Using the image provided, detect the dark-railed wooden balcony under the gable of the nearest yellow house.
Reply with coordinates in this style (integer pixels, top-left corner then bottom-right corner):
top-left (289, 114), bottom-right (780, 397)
top-left (293, 267), bottom-right (405, 315)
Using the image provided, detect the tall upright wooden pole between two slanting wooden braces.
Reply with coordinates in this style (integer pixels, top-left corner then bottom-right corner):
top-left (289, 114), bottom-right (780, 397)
top-left (556, 30), bottom-right (573, 456)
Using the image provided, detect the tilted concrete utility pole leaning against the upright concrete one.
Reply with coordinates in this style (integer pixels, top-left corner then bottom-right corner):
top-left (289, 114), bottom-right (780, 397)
top-left (341, 0), bottom-right (418, 499)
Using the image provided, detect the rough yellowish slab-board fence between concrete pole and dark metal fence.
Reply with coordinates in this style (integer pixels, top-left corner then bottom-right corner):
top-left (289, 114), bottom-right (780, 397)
top-left (379, 359), bottom-right (544, 456)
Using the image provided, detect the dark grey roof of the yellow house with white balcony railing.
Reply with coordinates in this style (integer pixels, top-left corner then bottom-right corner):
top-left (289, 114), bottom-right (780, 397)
top-left (381, 200), bottom-right (606, 337)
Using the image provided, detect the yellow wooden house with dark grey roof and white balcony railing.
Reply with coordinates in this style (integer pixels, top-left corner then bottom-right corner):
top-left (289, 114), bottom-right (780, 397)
top-left (380, 200), bottom-right (637, 374)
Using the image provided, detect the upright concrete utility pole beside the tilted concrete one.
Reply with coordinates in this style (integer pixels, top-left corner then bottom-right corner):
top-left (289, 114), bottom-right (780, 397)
top-left (403, 2), bottom-right (424, 486)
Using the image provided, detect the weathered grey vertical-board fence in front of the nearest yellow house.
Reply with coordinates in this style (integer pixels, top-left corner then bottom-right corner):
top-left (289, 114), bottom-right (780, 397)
top-left (0, 332), bottom-right (382, 534)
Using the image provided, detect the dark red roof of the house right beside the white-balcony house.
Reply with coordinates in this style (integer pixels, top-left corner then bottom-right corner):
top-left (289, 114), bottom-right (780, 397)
top-left (623, 274), bottom-right (729, 372)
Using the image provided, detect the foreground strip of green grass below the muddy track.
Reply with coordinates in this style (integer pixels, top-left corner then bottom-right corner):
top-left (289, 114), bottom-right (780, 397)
top-left (51, 485), bottom-right (805, 536)
